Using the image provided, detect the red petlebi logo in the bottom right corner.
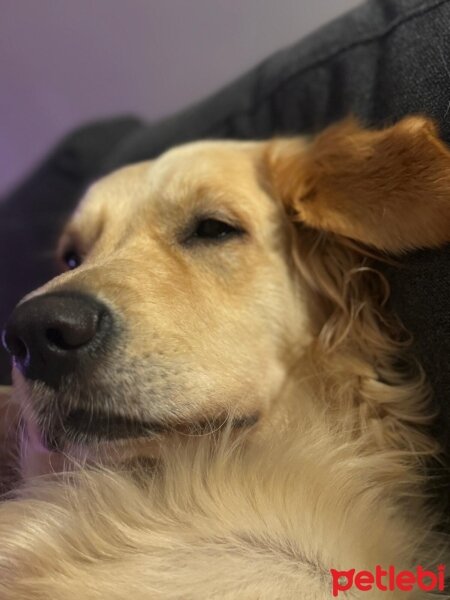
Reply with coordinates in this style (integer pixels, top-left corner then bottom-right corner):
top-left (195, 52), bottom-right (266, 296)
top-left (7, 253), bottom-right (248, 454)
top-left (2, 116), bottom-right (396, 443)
top-left (330, 565), bottom-right (445, 597)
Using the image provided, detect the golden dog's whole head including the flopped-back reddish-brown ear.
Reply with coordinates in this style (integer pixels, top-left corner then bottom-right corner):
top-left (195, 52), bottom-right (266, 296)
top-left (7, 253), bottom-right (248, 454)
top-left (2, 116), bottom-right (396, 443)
top-left (4, 118), bottom-right (449, 460)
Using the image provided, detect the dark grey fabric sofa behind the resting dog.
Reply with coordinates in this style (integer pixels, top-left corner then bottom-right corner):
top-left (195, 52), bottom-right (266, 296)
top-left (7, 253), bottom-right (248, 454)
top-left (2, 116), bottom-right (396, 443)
top-left (0, 0), bottom-right (450, 450)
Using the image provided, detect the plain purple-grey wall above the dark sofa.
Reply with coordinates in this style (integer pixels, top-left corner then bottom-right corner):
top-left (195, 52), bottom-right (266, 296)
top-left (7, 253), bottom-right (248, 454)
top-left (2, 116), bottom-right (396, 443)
top-left (0, 0), bottom-right (359, 194)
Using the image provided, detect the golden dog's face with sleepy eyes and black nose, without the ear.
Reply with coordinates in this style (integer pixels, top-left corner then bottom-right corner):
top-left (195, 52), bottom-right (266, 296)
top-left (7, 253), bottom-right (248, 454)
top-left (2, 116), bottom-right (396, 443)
top-left (7, 142), bottom-right (310, 448)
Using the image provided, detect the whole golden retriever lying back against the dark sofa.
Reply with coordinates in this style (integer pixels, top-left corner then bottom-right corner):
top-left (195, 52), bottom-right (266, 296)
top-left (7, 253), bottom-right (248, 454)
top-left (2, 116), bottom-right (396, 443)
top-left (0, 117), bottom-right (450, 600)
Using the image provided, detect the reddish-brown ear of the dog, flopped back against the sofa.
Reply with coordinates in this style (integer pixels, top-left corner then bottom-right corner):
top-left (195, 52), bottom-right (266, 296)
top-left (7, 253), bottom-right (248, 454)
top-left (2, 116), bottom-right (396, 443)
top-left (265, 116), bottom-right (450, 252)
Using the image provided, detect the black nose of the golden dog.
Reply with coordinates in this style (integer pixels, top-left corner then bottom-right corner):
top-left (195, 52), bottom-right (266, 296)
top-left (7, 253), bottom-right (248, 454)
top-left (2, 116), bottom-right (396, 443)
top-left (3, 292), bottom-right (113, 388)
